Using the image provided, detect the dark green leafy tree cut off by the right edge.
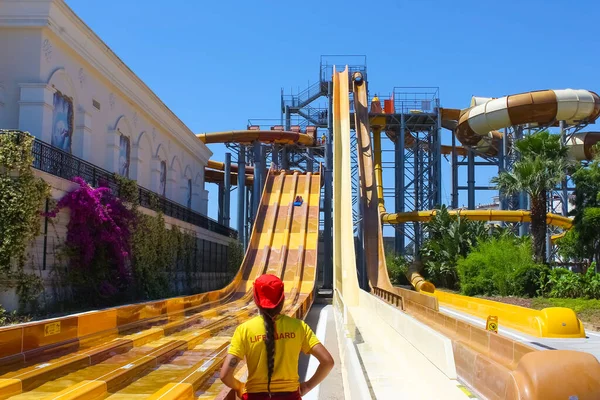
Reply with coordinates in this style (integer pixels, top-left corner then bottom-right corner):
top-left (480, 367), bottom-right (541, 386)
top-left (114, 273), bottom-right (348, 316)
top-left (559, 152), bottom-right (600, 265)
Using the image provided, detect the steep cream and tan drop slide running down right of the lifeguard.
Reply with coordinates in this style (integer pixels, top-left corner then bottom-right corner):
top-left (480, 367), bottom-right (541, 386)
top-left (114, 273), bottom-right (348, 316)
top-left (334, 67), bottom-right (600, 400)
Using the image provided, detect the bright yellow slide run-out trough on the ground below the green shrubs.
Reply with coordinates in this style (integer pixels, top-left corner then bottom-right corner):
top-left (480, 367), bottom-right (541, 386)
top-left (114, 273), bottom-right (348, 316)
top-left (434, 290), bottom-right (585, 338)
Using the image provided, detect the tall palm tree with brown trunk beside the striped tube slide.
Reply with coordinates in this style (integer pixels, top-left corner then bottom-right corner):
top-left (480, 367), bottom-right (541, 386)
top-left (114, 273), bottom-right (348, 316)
top-left (492, 131), bottom-right (569, 263)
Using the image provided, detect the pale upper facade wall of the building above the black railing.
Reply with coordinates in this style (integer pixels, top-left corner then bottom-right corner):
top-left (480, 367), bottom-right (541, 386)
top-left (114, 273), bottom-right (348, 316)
top-left (0, 0), bottom-right (212, 215)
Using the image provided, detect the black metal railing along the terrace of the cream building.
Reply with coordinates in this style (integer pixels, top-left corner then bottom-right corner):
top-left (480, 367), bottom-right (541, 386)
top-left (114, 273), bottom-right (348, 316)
top-left (5, 130), bottom-right (237, 238)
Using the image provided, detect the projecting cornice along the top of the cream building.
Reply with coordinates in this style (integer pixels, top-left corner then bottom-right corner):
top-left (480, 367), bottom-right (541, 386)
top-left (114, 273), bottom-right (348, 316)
top-left (0, 0), bottom-right (212, 163)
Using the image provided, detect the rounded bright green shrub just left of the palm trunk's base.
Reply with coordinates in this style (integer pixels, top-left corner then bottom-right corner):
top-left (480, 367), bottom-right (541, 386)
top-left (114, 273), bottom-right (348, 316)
top-left (457, 236), bottom-right (547, 296)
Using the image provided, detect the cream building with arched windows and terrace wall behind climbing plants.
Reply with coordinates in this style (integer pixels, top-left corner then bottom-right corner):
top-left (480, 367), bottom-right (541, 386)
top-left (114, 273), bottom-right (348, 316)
top-left (0, 0), bottom-right (237, 310)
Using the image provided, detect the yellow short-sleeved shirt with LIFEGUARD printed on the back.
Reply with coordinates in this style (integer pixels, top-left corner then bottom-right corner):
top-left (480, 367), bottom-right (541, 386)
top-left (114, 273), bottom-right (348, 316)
top-left (229, 314), bottom-right (320, 393)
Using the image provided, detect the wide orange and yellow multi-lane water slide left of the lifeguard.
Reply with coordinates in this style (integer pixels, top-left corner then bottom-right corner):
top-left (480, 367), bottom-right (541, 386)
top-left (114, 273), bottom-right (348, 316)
top-left (0, 169), bottom-right (321, 400)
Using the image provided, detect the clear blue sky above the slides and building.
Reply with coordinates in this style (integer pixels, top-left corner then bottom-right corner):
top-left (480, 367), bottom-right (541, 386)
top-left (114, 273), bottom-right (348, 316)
top-left (67, 0), bottom-right (600, 226)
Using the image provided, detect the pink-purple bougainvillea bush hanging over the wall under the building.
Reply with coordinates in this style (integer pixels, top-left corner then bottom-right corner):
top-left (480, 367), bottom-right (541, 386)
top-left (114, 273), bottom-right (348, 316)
top-left (48, 177), bottom-right (135, 297)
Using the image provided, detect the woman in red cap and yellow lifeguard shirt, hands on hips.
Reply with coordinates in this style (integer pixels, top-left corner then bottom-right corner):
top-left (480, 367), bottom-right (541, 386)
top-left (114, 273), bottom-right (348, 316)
top-left (221, 274), bottom-right (333, 400)
